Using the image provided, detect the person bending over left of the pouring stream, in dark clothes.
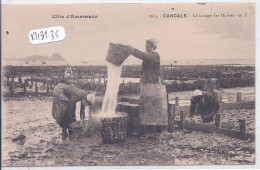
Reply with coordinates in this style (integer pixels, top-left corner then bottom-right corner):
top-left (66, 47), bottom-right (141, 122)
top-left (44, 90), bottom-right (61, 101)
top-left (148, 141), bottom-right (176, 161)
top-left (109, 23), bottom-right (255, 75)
top-left (52, 82), bottom-right (95, 140)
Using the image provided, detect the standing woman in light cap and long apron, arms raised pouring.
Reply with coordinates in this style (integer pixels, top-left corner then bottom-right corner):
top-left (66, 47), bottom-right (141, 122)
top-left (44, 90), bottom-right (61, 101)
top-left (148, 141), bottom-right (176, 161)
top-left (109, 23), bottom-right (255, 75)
top-left (126, 39), bottom-right (168, 133)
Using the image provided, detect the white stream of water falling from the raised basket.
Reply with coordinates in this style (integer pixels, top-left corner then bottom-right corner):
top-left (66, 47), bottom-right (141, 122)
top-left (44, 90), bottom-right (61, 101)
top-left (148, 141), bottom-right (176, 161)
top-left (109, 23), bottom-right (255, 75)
top-left (101, 62), bottom-right (122, 117)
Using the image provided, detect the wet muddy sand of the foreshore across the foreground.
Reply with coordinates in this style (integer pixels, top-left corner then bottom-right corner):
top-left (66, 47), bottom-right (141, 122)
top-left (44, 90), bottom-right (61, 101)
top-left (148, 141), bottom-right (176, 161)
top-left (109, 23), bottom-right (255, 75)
top-left (2, 88), bottom-right (255, 166)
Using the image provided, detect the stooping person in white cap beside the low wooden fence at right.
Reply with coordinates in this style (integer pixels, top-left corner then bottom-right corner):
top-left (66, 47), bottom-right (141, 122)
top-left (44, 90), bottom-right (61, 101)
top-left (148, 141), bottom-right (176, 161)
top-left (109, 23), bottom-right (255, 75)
top-left (189, 90), bottom-right (220, 123)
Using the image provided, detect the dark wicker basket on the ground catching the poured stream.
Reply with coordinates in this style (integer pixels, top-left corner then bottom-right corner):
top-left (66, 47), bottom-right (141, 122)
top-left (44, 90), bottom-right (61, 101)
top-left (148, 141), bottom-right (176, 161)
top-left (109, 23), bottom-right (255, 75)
top-left (101, 112), bottom-right (127, 143)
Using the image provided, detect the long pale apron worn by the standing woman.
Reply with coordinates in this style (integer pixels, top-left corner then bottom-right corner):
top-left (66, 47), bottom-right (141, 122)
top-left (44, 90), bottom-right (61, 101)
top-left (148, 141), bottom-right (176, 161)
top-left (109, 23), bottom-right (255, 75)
top-left (139, 79), bottom-right (168, 125)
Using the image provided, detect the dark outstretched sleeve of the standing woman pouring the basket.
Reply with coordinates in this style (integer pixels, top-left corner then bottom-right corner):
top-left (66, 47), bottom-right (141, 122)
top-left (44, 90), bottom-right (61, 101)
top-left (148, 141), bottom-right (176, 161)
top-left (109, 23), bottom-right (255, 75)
top-left (132, 49), bottom-right (160, 63)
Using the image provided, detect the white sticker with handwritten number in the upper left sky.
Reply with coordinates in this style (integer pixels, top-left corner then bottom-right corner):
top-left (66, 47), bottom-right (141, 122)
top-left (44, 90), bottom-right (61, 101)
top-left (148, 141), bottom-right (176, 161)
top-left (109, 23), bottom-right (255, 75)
top-left (29, 26), bottom-right (65, 44)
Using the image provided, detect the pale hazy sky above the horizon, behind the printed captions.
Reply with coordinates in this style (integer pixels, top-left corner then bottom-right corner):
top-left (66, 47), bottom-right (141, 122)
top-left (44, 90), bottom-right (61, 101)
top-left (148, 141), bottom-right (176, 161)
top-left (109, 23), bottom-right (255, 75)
top-left (2, 3), bottom-right (255, 64)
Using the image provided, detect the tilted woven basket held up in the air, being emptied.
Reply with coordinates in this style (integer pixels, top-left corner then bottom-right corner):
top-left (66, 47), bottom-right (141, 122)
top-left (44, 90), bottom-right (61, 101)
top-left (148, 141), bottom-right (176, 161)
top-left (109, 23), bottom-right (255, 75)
top-left (106, 43), bottom-right (131, 66)
